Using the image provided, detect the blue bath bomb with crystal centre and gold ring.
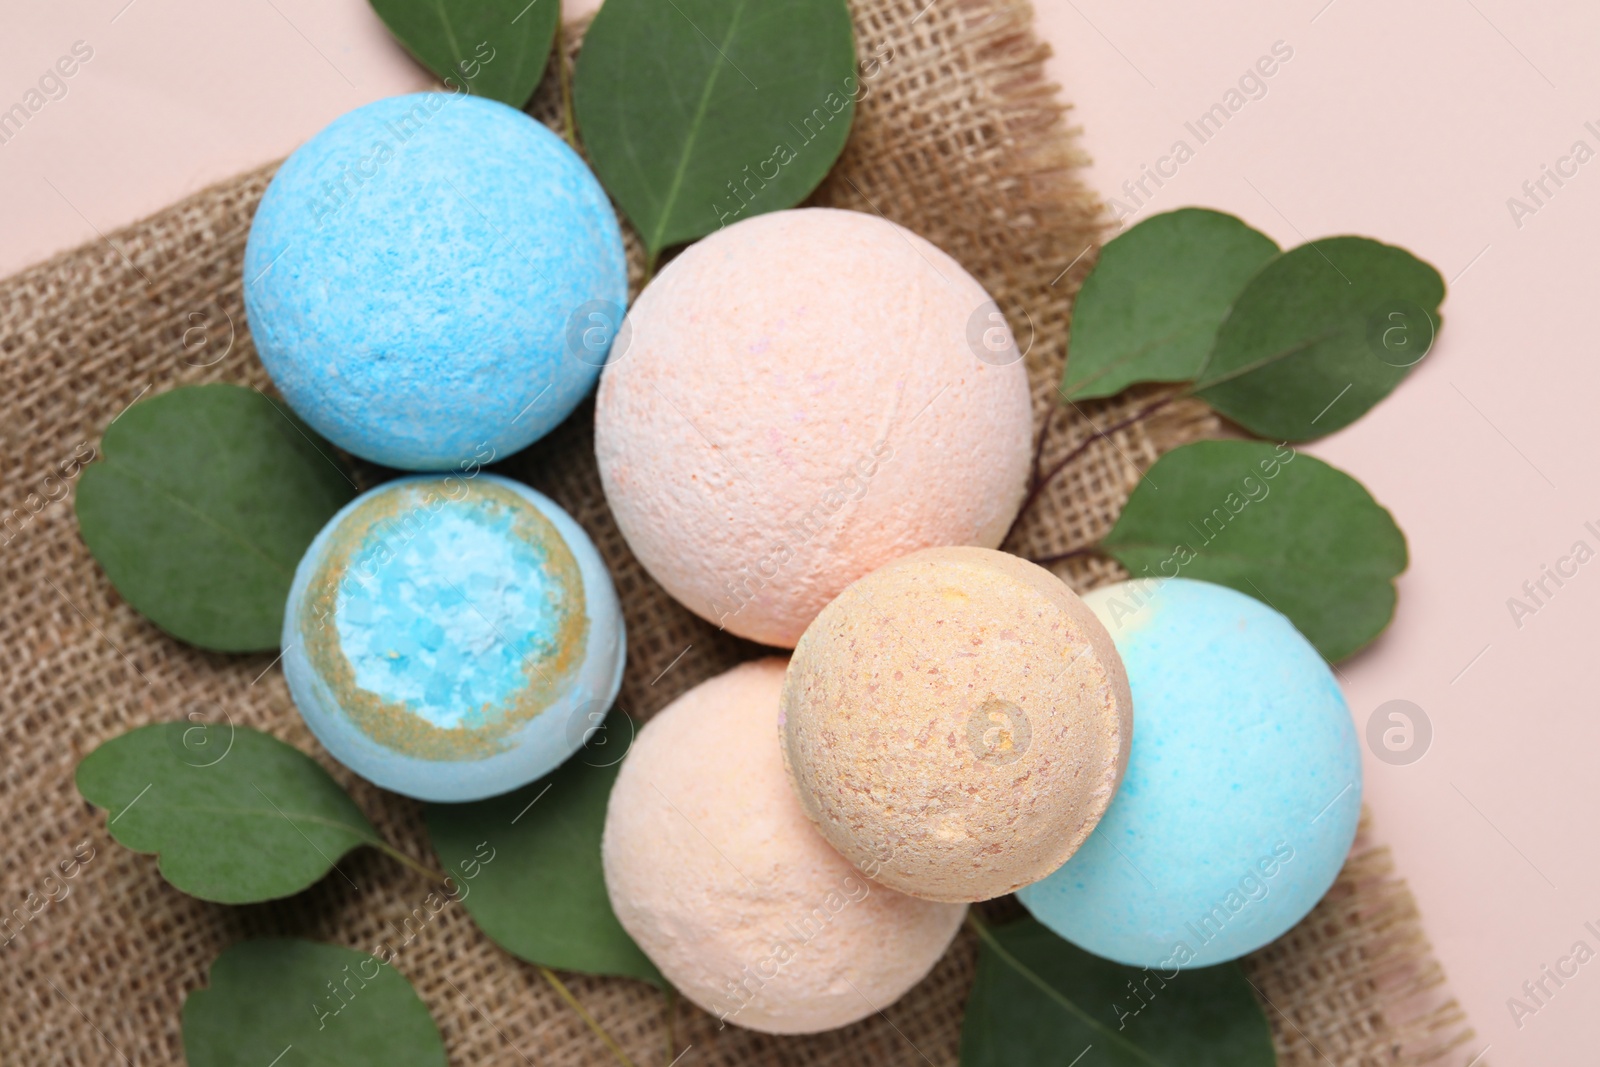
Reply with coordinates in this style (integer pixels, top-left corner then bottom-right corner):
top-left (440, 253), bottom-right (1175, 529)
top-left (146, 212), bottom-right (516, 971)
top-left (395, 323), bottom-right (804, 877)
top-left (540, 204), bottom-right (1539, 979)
top-left (283, 474), bottom-right (626, 801)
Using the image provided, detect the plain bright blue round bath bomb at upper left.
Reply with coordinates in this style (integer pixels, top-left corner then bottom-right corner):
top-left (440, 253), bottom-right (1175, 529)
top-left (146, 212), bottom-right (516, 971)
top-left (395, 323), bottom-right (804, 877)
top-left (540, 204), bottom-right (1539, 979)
top-left (245, 93), bottom-right (627, 470)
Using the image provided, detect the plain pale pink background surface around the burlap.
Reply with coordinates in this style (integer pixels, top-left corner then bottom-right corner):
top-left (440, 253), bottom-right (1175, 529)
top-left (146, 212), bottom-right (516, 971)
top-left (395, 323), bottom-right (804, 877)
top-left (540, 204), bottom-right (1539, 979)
top-left (0, 0), bottom-right (1600, 1067)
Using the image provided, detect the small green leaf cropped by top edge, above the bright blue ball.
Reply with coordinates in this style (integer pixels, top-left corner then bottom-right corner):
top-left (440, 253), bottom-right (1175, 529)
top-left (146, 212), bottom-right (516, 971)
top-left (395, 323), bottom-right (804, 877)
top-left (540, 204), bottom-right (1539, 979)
top-left (371, 0), bottom-right (562, 109)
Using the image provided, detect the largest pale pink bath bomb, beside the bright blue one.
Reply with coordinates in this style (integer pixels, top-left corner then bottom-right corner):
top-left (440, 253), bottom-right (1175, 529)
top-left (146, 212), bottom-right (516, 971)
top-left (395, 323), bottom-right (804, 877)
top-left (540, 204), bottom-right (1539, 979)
top-left (595, 208), bottom-right (1032, 648)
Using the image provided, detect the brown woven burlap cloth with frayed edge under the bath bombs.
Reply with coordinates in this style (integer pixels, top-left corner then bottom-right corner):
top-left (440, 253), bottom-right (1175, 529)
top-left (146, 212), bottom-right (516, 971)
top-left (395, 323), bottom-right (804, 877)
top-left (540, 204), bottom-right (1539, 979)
top-left (0, 0), bottom-right (1470, 1067)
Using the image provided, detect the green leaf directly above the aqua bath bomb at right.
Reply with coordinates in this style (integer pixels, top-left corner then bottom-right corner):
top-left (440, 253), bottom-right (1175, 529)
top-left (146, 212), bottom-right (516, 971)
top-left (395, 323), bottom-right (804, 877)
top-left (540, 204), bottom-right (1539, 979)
top-left (1101, 442), bottom-right (1406, 662)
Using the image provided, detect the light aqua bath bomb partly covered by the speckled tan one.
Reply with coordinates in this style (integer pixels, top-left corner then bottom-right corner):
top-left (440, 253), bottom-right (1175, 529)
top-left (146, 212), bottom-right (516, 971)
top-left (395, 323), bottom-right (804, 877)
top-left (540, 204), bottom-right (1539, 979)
top-left (1018, 579), bottom-right (1362, 971)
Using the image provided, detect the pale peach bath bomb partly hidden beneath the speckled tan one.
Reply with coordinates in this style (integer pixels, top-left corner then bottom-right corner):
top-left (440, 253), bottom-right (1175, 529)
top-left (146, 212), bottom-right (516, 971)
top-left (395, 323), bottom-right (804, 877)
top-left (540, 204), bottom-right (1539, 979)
top-left (600, 659), bottom-right (966, 1033)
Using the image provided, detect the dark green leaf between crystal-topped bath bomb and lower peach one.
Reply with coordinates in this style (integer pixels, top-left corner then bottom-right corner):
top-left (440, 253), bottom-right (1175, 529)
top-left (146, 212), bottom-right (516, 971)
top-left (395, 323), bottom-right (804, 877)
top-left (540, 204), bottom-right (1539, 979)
top-left (427, 713), bottom-right (667, 989)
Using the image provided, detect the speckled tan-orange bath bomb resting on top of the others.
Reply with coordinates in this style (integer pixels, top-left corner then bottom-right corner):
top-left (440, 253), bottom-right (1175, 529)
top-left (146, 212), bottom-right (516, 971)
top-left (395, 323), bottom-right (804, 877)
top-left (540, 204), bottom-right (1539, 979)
top-left (782, 549), bottom-right (1133, 901)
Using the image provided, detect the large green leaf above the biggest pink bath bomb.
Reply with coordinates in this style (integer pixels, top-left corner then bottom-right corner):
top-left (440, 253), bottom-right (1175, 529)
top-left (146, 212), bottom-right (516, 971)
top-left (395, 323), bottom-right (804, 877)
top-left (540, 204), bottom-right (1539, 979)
top-left (573, 0), bottom-right (864, 256)
